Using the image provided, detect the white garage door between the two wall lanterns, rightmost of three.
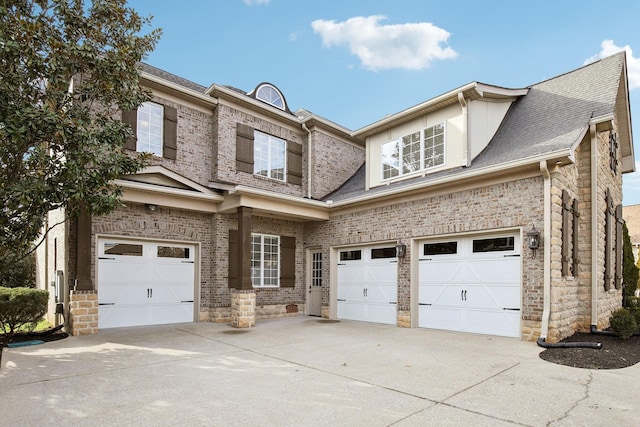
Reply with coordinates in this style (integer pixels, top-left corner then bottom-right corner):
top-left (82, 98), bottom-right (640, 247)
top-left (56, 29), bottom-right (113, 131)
top-left (418, 234), bottom-right (522, 337)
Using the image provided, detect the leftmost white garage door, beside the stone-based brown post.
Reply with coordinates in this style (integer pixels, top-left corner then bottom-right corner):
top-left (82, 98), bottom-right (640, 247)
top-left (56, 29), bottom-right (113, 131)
top-left (98, 238), bottom-right (195, 328)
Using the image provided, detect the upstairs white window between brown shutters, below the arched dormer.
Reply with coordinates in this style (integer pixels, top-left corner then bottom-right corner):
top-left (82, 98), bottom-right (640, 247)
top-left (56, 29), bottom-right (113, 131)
top-left (253, 131), bottom-right (287, 181)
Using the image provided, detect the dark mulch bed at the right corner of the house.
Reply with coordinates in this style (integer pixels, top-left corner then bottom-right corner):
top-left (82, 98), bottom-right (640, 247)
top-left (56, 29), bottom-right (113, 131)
top-left (540, 333), bottom-right (640, 369)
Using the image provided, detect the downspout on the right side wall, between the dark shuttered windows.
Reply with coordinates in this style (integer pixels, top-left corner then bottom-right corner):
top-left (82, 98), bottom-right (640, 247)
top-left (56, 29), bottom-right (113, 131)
top-left (589, 123), bottom-right (598, 329)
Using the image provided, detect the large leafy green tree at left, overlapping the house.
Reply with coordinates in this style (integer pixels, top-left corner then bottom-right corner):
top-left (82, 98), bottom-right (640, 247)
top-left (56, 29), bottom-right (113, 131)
top-left (0, 0), bottom-right (161, 273)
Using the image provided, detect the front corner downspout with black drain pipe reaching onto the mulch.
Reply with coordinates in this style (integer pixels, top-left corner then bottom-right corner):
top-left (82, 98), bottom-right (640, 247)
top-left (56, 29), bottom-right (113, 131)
top-left (537, 160), bottom-right (602, 350)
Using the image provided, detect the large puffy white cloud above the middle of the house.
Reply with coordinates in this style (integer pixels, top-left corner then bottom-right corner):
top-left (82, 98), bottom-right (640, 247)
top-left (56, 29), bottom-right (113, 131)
top-left (311, 15), bottom-right (458, 71)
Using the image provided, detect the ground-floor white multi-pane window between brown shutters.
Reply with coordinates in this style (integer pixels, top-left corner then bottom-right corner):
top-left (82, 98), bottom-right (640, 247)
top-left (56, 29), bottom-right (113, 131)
top-left (251, 234), bottom-right (280, 288)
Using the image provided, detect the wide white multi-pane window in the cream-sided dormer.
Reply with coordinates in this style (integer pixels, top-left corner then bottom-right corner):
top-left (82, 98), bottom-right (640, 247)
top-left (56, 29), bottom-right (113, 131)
top-left (382, 122), bottom-right (444, 179)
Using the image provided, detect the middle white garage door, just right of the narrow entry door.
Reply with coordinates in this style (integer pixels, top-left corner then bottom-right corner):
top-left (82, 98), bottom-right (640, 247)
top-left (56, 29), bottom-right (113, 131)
top-left (338, 246), bottom-right (398, 325)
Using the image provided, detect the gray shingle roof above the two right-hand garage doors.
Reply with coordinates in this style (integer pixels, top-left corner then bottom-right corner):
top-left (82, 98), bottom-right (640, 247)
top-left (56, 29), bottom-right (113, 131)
top-left (325, 52), bottom-right (625, 201)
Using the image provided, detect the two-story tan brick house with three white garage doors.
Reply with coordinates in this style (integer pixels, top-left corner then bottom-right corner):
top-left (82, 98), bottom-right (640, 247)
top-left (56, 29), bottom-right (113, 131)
top-left (40, 53), bottom-right (635, 342)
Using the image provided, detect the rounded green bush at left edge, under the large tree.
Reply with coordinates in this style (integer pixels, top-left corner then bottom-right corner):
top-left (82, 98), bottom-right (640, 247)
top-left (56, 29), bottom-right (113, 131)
top-left (0, 287), bottom-right (49, 336)
